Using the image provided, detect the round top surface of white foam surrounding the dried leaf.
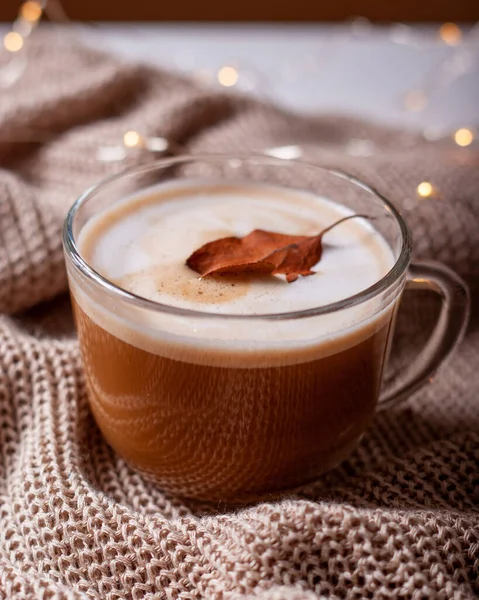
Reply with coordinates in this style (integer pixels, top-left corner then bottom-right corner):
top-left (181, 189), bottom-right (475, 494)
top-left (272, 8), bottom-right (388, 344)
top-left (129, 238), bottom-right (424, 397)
top-left (80, 183), bottom-right (393, 314)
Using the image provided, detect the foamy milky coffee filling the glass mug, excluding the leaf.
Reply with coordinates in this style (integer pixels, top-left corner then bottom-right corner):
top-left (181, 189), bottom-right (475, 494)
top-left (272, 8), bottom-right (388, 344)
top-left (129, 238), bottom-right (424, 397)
top-left (71, 180), bottom-right (394, 500)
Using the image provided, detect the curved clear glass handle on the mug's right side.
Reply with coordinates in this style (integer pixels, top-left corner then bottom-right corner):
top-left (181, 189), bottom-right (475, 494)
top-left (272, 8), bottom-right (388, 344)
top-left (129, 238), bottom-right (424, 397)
top-left (378, 261), bottom-right (470, 410)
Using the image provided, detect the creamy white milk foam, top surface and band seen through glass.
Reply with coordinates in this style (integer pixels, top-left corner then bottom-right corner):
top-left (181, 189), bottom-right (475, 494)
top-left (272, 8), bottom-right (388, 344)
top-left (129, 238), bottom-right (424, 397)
top-left (73, 180), bottom-right (394, 364)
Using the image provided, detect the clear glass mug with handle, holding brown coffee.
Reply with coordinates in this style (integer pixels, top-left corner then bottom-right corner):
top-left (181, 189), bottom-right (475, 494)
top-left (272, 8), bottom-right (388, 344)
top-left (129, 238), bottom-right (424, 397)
top-left (63, 156), bottom-right (469, 502)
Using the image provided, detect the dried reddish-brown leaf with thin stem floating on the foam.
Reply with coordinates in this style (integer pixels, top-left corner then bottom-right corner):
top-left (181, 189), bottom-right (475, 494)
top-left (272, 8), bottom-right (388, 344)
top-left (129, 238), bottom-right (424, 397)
top-left (186, 215), bottom-right (368, 283)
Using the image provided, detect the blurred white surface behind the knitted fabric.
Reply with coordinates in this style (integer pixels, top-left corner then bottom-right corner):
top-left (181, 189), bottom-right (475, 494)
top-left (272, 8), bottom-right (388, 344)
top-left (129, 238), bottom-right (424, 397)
top-left (0, 23), bottom-right (479, 128)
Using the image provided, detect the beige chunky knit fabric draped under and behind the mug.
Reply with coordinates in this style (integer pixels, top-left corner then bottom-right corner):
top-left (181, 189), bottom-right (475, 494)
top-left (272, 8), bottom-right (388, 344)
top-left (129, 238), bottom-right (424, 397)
top-left (0, 32), bottom-right (479, 600)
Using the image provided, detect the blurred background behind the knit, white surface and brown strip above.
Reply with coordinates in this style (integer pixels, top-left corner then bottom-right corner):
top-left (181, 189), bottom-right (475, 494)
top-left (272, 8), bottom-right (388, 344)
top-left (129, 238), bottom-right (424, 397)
top-left (0, 0), bottom-right (479, 139)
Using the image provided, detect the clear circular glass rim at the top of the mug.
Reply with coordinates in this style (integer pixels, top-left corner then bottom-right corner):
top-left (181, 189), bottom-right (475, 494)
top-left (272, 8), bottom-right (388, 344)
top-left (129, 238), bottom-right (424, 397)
top-left (63, 154), bottom-right (411, 320)
